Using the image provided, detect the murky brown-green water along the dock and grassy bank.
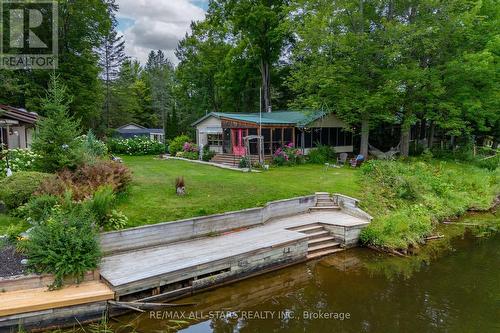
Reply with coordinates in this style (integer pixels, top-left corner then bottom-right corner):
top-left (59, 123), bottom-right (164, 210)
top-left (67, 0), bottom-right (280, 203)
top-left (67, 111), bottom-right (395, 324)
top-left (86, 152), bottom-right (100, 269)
top-left (114, 216), bottom-right (500, 333)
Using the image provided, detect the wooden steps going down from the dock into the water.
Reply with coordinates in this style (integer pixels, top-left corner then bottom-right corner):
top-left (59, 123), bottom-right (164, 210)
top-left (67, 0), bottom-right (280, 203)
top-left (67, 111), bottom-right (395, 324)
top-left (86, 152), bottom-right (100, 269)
top-left (288, 223), bottom-right (344, 259)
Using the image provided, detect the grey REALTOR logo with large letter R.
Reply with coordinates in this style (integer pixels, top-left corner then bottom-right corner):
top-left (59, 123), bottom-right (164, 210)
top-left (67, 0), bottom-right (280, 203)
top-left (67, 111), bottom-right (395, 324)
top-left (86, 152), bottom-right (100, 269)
top-left (0, 0), bottom-right (58, 69)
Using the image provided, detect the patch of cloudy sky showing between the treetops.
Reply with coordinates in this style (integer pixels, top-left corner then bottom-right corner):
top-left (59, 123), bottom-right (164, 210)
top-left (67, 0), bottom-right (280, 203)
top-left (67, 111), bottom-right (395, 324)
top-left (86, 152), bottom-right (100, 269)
top-left (117, 0), bottom-right (205, 64)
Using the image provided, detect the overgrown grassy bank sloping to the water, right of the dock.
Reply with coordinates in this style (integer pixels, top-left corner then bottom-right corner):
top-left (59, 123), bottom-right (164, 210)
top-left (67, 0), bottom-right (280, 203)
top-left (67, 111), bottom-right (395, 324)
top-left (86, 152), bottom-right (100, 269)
top-left (361, 160), bottom-right (500, 250)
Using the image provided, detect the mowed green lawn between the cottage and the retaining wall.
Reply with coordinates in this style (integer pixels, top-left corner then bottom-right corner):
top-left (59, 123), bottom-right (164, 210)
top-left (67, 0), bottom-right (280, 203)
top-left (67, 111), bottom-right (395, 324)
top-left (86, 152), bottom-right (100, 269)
top-left (118, 156), bottom-right (360, 227)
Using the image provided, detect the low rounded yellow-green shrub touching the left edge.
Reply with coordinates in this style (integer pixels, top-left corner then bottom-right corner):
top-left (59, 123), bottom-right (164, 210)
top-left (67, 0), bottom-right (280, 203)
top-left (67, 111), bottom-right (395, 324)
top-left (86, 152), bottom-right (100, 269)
top-left (0, 171), bottom-right (53, 209)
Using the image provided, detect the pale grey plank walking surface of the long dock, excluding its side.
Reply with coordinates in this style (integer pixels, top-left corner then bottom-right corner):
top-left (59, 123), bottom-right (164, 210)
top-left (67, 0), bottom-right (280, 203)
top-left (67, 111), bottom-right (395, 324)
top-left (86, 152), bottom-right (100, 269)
top-left (100, 210), bottom-right (369, 294)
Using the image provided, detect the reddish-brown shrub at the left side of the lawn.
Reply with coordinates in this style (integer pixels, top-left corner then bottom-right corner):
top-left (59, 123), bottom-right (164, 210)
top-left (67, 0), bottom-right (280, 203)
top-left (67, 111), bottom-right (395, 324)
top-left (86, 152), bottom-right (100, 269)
top-left (37, 161), bottom-right (132, 201)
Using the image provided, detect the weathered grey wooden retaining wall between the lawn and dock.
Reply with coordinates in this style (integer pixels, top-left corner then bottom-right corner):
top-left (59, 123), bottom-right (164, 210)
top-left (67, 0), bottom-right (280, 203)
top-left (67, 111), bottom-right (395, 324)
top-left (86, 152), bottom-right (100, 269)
top-left (100, 195), bottom-right (316, 255)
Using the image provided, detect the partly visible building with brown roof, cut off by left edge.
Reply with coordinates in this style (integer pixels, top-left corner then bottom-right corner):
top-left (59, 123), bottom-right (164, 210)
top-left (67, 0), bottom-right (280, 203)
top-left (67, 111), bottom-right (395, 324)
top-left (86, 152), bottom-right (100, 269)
top-left (0, 104), bottom-right (38, 149)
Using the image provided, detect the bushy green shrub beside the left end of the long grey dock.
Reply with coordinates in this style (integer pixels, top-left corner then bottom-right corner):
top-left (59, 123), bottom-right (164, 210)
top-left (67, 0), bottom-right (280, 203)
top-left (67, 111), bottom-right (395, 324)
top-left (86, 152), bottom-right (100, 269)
top-left (26, 207), bottom-right (101, 288)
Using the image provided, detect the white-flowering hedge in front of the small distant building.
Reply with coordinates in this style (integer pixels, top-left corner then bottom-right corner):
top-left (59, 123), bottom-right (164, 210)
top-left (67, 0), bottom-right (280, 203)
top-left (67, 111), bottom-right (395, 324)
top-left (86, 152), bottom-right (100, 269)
top-left (107, 137), bottom-right (165, 155)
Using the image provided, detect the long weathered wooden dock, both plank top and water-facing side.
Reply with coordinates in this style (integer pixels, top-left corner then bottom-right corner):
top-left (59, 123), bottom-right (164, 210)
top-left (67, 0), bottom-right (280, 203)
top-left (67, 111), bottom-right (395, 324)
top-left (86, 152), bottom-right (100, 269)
top-left (101, 210), bottom-right (369, 296)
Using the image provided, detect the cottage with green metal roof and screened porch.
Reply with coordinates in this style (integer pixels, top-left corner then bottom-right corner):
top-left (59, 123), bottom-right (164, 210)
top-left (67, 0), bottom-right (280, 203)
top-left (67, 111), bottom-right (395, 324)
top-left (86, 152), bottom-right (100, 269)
top-left (192, 111), bottom-right (354, 156)
